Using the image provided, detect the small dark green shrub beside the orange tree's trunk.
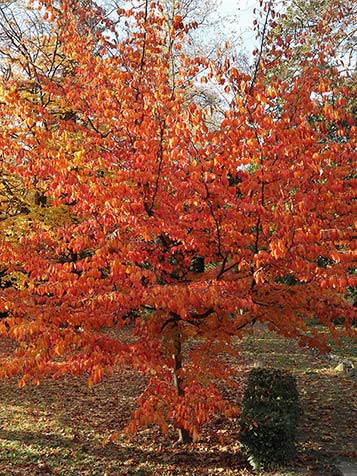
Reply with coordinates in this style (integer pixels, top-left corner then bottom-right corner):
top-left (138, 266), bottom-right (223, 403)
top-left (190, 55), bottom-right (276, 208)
top-left (239, 368), bottom-right (299, 469)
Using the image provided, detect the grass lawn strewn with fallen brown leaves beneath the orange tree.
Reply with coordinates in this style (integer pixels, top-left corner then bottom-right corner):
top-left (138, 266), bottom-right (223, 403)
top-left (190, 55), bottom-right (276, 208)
top-left (0, 329), bottom-right (357, 476)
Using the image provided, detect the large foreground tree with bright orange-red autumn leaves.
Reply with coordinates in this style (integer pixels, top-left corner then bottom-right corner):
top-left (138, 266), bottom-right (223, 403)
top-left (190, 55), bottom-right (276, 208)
top-left (0, 0), bottom-right (357, 441)
